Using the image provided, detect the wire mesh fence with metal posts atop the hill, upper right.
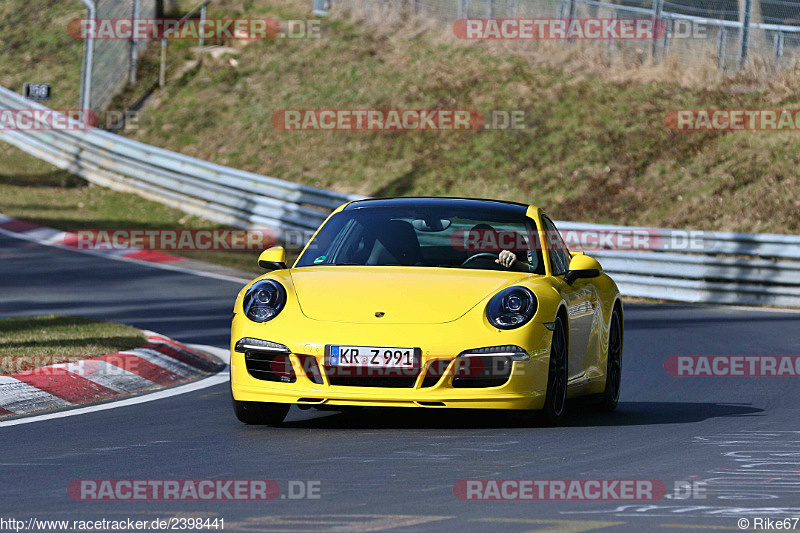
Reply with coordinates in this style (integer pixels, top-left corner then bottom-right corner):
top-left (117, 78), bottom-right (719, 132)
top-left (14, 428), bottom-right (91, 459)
top-left (333, 0), bottom-right (800, 70)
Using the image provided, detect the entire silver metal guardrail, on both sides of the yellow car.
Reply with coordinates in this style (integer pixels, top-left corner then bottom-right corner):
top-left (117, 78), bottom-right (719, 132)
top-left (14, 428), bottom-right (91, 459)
top-left (0, 87), bottom-right (800, 308)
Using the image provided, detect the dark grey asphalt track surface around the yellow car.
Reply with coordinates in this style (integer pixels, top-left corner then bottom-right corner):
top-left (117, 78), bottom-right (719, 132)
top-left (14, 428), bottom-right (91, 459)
top-left (0, 235), bottom-right (800, 532)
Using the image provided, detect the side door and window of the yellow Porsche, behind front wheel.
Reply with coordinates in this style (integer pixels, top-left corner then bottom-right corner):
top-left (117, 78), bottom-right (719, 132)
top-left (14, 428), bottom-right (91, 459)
top-left (542, 216), bottom-right (597, 379)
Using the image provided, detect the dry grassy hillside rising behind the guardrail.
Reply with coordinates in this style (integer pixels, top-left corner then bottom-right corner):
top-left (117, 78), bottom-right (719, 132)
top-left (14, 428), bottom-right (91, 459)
top-left (0, 0), bottom-right (800, 233)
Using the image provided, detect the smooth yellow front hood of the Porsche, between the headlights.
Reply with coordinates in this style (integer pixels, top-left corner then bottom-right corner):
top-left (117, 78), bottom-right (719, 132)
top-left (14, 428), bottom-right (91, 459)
top-left (291, 266), bottom-right (529, 324)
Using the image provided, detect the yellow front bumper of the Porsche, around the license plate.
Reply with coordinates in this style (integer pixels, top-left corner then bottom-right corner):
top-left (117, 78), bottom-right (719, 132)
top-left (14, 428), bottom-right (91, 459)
top-left (231, 315), bottom-right (552, 409)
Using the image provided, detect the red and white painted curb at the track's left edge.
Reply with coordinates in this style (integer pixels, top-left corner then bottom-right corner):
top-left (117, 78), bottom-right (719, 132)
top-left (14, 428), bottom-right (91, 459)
top-left (0, 331), bottom-right (225, 417)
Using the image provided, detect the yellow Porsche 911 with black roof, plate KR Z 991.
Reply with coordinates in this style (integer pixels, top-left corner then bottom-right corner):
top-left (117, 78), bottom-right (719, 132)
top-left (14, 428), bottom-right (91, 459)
top-left (231, 198), bottom-right (624, 425)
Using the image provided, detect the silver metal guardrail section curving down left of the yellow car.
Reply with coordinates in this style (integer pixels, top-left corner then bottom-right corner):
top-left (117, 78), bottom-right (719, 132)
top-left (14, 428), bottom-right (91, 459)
top-left (0, 87), bottom-right (360, 237)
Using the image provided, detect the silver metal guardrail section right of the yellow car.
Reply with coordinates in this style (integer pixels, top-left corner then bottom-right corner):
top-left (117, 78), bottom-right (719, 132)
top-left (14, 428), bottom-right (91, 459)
top-left (557, 222), bottom-right (800, 308)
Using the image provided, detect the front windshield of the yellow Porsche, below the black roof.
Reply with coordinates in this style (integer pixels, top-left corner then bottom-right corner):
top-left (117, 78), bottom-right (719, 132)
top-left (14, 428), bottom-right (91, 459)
top-left (295, 206), bottom-right (545, 274)
